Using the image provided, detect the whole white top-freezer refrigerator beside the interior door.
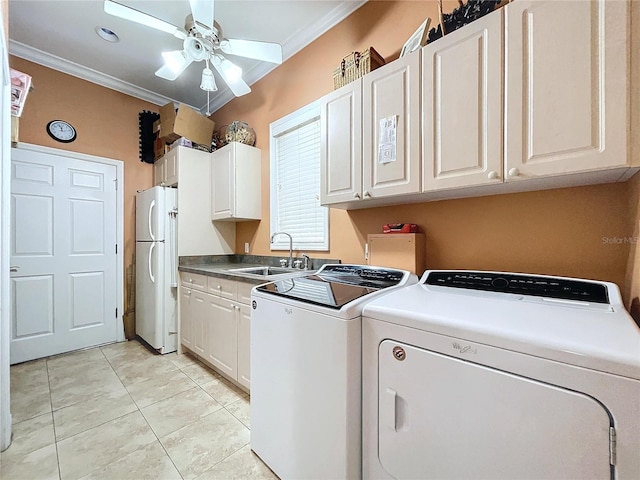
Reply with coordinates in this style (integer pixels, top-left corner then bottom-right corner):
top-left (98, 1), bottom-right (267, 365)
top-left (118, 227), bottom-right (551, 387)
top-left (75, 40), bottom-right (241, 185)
top-left (136, 187), bottom-right (178, 354)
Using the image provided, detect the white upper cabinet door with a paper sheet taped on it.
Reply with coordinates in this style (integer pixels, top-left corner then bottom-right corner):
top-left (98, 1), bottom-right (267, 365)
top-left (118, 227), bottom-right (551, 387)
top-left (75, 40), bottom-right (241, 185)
top-left (362, 52), bottom-right (420, 199)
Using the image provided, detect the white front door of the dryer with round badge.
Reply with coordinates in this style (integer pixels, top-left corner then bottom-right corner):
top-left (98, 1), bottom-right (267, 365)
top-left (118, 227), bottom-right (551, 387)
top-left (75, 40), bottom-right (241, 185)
top-left (378, 340), bottom-right (611, 480)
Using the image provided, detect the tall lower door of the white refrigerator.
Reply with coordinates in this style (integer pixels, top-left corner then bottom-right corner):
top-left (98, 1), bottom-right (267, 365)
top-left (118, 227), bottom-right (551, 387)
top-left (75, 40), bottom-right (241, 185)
top-left (136, 242), bottom-right (167, 349)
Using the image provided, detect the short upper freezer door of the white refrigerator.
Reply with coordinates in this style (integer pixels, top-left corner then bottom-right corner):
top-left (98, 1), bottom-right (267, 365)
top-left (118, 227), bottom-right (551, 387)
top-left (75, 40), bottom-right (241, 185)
top-left (136, 187), bottom-right (166, 242)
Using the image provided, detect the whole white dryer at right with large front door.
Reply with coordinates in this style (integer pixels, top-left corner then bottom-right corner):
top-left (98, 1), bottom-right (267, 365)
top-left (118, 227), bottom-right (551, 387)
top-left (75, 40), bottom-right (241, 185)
top-left (362, 271), bottom-right (640, 480)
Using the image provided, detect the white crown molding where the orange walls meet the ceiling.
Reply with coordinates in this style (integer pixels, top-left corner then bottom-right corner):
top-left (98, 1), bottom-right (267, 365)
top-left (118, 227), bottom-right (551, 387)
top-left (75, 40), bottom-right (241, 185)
top-left (9, 0), bottom-right (367, 113)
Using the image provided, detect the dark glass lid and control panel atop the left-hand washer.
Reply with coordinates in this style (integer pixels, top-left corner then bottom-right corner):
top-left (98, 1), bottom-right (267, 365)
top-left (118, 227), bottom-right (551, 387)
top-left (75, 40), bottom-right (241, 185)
top-left (256, 264), bottom-right (410, 309)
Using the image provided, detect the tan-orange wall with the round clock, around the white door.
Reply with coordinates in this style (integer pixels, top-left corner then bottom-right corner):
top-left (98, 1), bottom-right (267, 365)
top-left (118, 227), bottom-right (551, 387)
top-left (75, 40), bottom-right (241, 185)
top-left (9, 56), bottom-right (158, 311)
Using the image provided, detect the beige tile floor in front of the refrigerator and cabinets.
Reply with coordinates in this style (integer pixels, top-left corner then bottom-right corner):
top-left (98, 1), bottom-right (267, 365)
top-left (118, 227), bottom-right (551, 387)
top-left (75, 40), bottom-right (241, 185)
top-left (0, 341), bottom-right (277, 480)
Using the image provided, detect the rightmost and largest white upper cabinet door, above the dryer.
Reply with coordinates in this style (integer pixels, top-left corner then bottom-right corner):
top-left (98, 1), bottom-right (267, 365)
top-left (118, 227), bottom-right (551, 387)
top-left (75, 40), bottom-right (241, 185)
top-left (505, 0), bottom-right (629, 180)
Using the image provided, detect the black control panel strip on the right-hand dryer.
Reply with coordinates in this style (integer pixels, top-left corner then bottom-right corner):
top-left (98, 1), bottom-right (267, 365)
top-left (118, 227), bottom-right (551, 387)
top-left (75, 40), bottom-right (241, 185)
top-left (422, 271), bottom-right (609, 304)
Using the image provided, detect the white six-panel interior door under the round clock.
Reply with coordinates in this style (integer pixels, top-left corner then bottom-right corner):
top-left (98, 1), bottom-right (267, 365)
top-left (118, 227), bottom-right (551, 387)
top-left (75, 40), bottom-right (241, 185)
top-left (11, 149), bottom-right (119, 364)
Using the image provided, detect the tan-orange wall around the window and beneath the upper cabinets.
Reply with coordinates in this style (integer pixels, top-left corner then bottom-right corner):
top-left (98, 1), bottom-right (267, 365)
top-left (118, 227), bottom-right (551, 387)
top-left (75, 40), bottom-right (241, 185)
top-left (213, 1), bottom-right (640, 296)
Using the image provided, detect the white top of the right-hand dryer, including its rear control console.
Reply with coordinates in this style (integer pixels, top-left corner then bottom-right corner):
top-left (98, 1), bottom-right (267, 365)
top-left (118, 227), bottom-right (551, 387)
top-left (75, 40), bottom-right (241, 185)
top-left (362, 271), bottom-right (640, 379)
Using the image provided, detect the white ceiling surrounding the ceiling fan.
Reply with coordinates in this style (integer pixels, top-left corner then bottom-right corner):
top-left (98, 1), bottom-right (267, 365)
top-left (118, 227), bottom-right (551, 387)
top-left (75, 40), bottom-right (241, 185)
top-left (9, 0), bottom-right (366, 113)
